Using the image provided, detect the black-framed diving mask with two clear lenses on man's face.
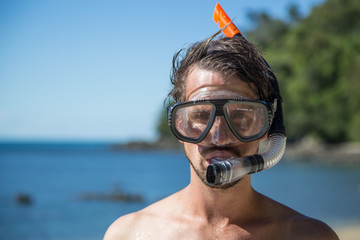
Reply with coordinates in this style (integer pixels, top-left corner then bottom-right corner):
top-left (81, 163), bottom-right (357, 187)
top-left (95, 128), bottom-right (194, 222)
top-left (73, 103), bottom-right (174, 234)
top-left (168, 90), bottom-right (276, 143)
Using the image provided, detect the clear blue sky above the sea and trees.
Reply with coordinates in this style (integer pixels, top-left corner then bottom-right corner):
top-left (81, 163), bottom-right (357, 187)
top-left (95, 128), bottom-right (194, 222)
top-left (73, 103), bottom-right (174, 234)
top-left (0, 0), bottom-right (323, 142)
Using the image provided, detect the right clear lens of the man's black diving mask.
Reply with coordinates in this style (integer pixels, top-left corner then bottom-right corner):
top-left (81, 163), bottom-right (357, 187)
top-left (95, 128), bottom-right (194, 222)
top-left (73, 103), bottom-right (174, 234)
top-left (225, 101), bottom-right (268, 140)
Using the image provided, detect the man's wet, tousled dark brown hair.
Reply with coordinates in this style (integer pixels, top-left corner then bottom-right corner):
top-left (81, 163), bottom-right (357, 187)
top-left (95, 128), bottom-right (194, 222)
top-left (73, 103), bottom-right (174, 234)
top-left (169, 31), bottom-right (273, 102)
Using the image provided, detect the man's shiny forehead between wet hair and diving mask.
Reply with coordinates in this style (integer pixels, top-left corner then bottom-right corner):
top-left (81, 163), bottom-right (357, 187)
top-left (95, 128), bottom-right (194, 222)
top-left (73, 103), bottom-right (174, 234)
top-left (185, 67), bottom-right (257, 101)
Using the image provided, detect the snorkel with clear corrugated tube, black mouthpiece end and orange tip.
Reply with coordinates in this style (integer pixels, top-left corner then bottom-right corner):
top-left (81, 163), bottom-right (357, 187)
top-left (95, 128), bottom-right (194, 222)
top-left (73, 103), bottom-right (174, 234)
top-left (206, 3), bottom-right (286, 186)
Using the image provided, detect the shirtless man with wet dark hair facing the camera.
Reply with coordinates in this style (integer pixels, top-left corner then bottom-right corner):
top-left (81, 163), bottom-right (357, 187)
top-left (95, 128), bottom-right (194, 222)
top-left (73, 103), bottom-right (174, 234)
top-left (105, 32), bottom-right (338, 240)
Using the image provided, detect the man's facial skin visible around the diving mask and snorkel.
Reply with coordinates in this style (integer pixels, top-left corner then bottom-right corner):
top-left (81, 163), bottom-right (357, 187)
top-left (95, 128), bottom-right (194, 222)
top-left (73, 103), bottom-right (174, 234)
top-left (184, 68), bottom-right (260, 187)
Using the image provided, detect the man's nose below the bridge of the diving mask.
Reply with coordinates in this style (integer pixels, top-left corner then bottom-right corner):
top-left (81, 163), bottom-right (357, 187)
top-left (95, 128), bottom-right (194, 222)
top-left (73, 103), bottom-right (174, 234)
top-left (206, 116), bottom-right (237, 146)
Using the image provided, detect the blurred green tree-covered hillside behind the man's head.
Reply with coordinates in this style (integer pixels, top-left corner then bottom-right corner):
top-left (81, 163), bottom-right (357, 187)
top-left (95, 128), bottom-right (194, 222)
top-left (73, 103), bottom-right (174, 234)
top-left (158, 0), bottom-right (360, 143)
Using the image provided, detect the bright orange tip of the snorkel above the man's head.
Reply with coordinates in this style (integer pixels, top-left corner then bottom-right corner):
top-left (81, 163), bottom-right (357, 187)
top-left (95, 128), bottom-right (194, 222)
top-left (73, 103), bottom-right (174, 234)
top-left (213, 3), bottom-right (241, 37)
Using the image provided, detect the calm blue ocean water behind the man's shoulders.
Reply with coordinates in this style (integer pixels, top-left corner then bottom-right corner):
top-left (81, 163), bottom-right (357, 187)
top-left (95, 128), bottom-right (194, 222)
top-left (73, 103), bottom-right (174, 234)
top-left (0, 143), bottom-right (360, 240)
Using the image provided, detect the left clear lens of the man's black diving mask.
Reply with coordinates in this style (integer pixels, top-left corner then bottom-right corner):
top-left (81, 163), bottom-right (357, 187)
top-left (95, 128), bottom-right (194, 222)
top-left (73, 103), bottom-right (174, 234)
top-left (175, 103), bottom-right (215, 140)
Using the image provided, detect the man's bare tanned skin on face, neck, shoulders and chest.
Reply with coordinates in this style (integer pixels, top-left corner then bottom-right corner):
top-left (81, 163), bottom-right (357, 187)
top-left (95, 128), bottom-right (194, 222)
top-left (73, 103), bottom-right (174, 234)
top-left (104, 67), bottom-right (339, 240)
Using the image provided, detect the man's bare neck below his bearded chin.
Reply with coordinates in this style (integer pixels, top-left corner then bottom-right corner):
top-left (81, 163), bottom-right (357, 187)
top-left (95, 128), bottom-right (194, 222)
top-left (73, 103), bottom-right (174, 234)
top-left (185, 170), bottom-right (256, 223)
